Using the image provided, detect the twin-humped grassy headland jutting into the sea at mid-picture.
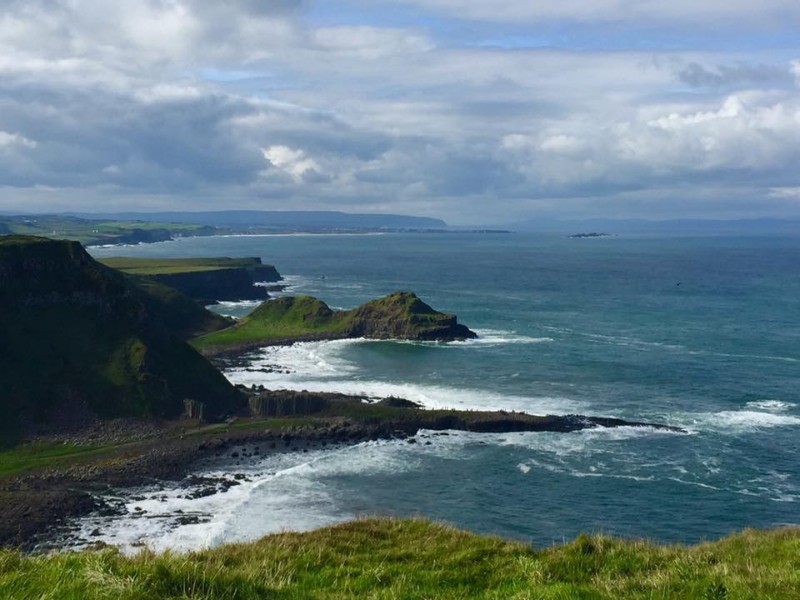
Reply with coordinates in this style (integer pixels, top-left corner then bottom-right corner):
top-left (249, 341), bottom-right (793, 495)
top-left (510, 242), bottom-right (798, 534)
top-left (192, 292), bottom-right (476, 354)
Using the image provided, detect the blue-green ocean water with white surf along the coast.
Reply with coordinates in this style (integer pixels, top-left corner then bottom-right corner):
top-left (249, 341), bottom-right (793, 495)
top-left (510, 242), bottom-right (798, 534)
top-left (82, 234), bottom-right (800, 549)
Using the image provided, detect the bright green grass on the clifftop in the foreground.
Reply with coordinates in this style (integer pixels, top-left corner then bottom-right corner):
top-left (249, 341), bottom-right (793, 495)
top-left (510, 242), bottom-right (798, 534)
top-left (0, 520), bottom-right (800, 600)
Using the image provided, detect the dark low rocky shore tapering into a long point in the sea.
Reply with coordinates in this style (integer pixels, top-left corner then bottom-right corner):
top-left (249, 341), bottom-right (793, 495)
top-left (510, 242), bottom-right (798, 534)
top-left (0, 392), bottom-right (681, 550)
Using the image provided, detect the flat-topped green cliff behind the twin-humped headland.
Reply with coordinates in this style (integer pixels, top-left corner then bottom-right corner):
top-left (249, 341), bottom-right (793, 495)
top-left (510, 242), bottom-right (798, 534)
top-left (101, 257), bottom-right (282, 304)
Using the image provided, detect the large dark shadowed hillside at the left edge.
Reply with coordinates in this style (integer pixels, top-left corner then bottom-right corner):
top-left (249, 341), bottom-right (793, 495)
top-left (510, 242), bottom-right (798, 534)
top-left (0, 236), bottom-right (242, 440)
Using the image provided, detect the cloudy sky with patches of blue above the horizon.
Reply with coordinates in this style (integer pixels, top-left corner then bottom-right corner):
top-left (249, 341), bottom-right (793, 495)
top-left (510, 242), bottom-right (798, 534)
top-left (0, 0), bottom-right (800, 225)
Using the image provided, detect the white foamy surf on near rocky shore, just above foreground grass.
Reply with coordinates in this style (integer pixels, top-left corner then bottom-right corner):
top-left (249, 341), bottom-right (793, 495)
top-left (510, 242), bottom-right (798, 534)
top-left (71, 434), bottom-right (460, 553)
